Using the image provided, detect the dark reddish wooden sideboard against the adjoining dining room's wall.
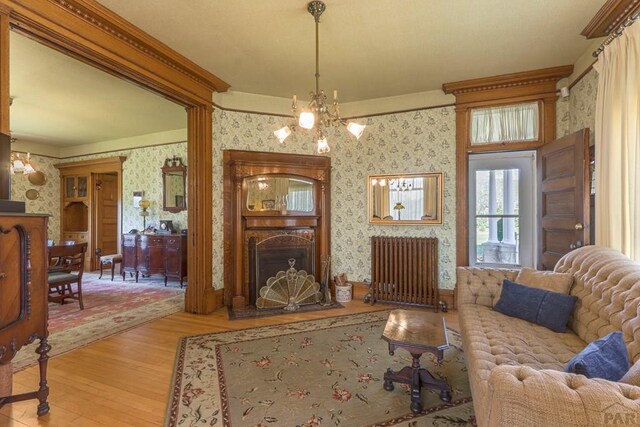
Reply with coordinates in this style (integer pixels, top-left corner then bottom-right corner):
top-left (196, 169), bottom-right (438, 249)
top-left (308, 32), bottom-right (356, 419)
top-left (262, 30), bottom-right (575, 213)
top-left (122, 234), bottom-right (187, 287)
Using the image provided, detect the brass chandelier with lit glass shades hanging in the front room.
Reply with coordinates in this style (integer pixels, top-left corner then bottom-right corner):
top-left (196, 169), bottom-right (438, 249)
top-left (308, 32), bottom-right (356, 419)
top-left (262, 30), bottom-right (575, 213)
top-left (274, 0), bottom-right (365, 154)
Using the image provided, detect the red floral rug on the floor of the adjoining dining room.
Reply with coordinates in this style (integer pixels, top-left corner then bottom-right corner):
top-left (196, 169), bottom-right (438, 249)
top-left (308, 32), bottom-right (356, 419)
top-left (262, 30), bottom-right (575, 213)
top-left (13, 273), bottom-right (184, 372)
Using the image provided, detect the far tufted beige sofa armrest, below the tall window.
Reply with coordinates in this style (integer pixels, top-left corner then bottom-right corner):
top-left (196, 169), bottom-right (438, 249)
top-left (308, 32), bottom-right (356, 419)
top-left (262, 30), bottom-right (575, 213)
top-left (456, 267), bottom-right (519, 307)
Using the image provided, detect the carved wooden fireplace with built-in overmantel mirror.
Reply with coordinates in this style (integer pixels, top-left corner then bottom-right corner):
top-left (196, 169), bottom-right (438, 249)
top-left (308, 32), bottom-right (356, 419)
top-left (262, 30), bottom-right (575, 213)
top-left (223, 150), bottom-right (331, 310)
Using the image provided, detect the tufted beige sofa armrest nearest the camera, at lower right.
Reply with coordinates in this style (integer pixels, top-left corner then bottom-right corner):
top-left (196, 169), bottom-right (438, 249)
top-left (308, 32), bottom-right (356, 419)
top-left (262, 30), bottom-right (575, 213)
top-left (485, 365), bottom-right (640, 426)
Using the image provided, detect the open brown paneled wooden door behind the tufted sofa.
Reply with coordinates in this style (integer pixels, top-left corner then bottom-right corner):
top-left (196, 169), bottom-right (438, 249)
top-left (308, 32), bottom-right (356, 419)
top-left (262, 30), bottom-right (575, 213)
top-left (537, 129), bottom-right (590, 270)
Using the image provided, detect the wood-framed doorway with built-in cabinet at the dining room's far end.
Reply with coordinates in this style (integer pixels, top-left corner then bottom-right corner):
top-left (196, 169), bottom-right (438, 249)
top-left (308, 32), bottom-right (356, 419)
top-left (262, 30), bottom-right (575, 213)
top-left (52, 157), bottom-right (126, 271)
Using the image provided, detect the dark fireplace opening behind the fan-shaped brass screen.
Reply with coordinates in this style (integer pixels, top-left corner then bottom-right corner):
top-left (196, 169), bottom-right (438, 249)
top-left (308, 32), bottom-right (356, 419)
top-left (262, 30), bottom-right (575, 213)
top-left (249, 231), bottom-right (318, 306)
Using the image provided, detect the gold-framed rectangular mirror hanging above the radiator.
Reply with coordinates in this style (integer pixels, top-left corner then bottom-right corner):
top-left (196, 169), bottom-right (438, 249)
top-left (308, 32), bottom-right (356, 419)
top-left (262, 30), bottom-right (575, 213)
top-left (367, 172), bottom-right (443, 225)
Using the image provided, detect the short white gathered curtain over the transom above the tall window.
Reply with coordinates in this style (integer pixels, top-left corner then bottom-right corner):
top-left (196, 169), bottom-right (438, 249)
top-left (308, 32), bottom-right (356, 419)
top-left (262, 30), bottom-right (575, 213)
top-left (471, 102), bottom-right (538, 145)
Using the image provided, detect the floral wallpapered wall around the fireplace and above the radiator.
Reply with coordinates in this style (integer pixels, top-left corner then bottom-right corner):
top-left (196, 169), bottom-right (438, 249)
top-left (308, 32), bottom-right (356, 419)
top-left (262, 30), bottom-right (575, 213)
top-left (213, 107), bottom-right (455, 289)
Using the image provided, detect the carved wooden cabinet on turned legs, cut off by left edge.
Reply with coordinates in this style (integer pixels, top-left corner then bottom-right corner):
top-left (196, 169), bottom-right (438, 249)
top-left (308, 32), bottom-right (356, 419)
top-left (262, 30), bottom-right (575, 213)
top-left (0, 213), bottom-right (51, 415)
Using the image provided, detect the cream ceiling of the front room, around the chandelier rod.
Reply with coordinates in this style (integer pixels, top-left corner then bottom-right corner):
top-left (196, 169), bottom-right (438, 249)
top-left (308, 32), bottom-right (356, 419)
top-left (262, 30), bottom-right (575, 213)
top-left (98, 0), bottom-right (605, 102)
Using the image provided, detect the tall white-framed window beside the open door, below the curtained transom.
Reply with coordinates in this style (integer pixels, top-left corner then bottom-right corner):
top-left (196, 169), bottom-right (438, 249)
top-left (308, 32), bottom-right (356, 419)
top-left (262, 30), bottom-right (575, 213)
top-left (469, 151), bottom-right (535, 267)
